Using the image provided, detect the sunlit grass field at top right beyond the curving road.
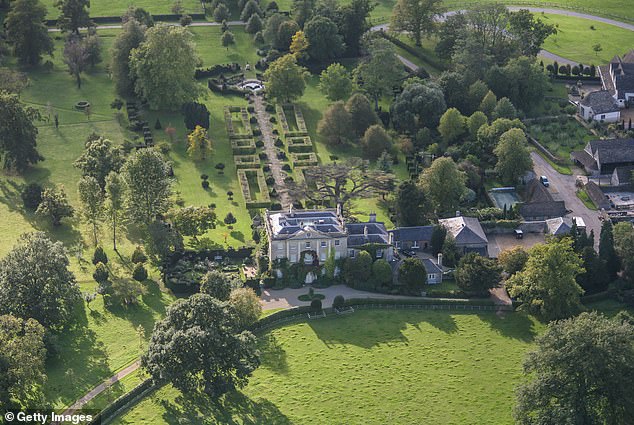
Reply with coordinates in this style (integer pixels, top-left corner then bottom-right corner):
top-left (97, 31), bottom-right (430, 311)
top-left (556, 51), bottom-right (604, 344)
top-left (539, 13), bottom-right (634, 65)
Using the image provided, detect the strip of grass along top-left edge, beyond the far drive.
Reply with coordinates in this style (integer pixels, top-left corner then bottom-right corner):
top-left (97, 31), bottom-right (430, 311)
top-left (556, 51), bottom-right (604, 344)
top-left (42, 0), bottom-right (203, 19)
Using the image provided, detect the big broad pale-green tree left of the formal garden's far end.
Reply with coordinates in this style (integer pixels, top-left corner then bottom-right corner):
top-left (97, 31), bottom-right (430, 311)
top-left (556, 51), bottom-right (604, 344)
top-left (130, 24), bottom-right (199, 109)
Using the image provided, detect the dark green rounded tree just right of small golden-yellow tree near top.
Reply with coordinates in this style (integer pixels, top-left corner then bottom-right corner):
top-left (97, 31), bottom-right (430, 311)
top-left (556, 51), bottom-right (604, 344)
top-left (304, 16), bottom-right (345, 62)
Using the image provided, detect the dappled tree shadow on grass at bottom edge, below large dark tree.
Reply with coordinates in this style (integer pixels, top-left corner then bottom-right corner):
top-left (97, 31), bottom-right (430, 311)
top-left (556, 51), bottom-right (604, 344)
top-left (161, 391), bottom-right (292, 425)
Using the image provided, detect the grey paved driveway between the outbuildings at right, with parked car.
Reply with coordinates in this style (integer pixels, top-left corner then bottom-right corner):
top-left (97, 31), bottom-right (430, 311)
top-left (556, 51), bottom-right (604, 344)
top-left (531, 152), bottom-right (601, 249)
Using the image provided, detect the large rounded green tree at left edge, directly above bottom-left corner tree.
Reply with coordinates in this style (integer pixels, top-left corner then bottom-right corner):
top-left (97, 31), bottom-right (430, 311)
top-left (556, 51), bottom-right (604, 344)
top-left (0, 232), bottom-right (81, 328)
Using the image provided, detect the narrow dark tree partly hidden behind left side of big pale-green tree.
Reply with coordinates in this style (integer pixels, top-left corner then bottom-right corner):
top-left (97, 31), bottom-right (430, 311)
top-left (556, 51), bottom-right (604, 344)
top-left (110, 19), bottom-right (146, 96)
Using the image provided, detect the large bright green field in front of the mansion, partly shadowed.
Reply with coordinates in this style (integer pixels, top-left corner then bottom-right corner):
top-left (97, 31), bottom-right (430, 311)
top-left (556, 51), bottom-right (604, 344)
top-left (115, 311), bottom-right (542, 424)
